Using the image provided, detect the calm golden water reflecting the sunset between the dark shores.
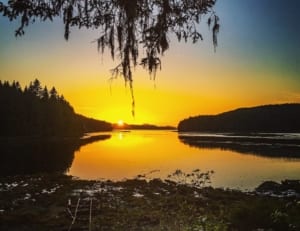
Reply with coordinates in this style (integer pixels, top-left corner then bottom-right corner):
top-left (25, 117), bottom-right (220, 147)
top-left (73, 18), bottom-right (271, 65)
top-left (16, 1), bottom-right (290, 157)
top-left (68, 131), bottom-right (300, 189)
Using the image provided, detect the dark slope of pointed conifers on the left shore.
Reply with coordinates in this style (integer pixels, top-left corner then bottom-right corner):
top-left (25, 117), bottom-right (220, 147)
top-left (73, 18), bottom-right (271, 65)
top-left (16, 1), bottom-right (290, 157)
top-left (0, 79), bottom-right (112, 137)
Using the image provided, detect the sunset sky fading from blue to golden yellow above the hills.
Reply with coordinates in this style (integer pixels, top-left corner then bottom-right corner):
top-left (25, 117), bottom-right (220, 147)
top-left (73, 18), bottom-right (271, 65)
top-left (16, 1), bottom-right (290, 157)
top-left (0, 0), bottom-right (300, 125)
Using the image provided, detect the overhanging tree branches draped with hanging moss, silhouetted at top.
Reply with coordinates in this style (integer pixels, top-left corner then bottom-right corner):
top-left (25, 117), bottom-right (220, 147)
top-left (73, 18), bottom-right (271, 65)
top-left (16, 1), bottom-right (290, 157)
top-left (0, 0), bottom-right (220, 82)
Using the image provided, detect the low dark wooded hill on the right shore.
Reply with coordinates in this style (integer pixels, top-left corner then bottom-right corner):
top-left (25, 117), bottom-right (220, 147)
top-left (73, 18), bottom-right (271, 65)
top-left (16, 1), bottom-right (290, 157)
top-left (178, 103), bottom-right (300, 133)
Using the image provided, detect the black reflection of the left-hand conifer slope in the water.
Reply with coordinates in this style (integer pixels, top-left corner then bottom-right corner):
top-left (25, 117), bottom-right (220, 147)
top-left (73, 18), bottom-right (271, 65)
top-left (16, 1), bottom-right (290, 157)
top-left (0, 135), bottom-right (110, 175)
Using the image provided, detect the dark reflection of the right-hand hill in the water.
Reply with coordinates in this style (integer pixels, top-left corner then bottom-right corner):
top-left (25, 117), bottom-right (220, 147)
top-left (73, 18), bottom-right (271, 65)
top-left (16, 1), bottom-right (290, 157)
top-left (178, 136), bottom-right (300, 158)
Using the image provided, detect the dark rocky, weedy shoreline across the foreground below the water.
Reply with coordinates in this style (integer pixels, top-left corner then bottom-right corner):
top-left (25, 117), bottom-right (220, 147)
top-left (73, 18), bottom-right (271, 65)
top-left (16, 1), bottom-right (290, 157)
top-left (0, 171), bottom-right (300, 231)
